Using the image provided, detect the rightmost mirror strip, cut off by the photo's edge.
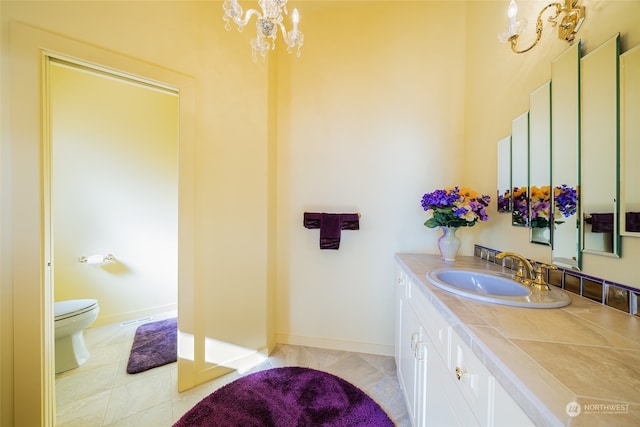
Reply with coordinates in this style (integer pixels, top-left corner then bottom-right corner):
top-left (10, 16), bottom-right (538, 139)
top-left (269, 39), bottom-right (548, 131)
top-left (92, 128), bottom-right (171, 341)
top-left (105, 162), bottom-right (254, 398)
top-left (620, 46), bottom-right (640, 237)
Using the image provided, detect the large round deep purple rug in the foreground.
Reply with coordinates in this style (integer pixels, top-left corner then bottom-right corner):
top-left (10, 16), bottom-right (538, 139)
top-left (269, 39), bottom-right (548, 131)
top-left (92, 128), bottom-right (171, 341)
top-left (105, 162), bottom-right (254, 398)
top-left (174, 367), bottom-right (393, 427)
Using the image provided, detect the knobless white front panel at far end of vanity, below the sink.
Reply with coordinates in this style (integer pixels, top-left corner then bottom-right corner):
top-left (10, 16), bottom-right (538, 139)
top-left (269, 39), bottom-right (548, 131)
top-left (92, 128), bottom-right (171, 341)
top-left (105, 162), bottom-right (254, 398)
top-left (411, 282), bottom-right (451, 363)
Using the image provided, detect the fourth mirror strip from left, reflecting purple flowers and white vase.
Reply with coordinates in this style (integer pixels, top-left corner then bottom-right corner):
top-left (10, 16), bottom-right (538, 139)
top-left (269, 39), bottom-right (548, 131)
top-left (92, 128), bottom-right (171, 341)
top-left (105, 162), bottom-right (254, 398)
top-left (551, 42), bottom-right (582, 270)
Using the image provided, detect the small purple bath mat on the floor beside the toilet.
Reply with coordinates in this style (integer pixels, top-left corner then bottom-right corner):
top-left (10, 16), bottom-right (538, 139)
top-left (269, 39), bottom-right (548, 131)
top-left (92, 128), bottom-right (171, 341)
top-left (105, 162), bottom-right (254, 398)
top-left (127, 318), bottom-right (178, 374)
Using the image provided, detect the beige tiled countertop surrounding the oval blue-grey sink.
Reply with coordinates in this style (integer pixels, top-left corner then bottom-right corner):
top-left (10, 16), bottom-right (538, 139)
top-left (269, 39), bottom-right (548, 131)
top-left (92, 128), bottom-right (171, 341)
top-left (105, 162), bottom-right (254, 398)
top-left (396, 254), bottom-right (640, 427)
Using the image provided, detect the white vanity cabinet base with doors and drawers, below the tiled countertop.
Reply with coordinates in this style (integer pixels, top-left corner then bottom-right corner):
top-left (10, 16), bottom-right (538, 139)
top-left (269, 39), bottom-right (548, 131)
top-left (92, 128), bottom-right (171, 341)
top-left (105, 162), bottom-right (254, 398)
top-left (395, 266), bottom-right (534, 427)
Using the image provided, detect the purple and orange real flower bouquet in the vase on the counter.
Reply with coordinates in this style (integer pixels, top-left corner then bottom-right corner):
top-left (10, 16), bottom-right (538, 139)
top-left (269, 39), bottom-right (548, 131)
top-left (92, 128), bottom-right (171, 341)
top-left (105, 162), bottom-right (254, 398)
top-left (422, 186), bottom-right (491, 228)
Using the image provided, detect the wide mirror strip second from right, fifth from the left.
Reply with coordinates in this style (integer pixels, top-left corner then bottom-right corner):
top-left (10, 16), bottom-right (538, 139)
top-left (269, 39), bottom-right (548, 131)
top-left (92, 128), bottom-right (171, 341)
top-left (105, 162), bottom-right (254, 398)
top-left (580, 34), bottom-right (620, 256)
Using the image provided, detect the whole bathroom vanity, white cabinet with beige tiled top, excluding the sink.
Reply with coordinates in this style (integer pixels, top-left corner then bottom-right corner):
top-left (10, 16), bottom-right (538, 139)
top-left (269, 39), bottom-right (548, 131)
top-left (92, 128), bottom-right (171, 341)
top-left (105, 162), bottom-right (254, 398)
top-left (395, 254), bottom-right (640, 427)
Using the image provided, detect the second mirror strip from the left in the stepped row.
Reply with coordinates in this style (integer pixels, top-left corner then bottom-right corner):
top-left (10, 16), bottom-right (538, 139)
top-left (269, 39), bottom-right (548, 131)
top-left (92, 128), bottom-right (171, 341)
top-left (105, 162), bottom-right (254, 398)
top-left (511, 112), bottom-right (529, 227)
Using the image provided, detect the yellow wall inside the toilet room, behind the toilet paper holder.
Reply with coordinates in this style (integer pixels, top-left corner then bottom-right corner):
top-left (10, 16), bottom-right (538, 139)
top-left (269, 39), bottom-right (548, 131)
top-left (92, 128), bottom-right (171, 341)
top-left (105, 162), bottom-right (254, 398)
top-left (49, 61), bottom-right (178, 326)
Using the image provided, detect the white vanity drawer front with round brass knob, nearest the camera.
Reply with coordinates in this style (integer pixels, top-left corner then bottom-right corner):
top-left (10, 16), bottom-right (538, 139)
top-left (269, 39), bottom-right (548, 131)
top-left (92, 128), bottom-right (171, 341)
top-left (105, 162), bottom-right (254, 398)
top-left (450, 333), bottom-right (495, 426)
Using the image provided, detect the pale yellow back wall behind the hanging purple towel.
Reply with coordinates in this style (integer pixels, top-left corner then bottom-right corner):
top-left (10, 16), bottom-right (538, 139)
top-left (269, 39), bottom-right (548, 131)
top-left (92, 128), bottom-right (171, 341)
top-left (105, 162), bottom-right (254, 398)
top-left (277, 2), bottom-right (464, 355)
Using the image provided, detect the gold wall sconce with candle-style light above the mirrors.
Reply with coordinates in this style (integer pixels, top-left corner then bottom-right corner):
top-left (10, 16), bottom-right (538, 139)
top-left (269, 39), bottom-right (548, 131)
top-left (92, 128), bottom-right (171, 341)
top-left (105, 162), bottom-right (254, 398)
top-left (498, 0), bottom-right (585, 53)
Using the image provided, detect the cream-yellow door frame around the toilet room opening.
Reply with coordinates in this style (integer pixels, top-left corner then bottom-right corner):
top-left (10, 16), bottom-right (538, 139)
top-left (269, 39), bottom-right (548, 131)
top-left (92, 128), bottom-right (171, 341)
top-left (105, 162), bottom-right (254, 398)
top-left (8, 22), bottom-right (196, 426)
